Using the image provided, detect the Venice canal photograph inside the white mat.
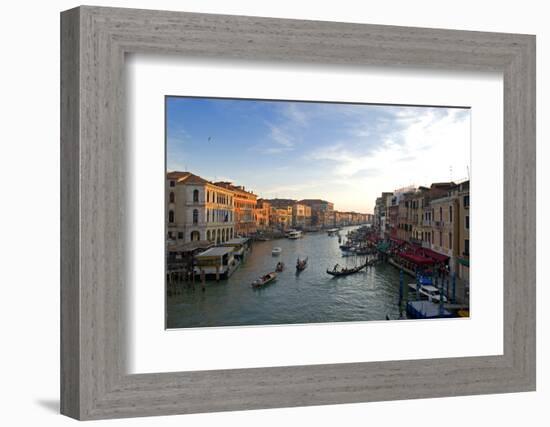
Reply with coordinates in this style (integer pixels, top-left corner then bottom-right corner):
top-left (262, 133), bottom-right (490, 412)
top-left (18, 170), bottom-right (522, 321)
top-left (164, 95), bottom-right (471, 329)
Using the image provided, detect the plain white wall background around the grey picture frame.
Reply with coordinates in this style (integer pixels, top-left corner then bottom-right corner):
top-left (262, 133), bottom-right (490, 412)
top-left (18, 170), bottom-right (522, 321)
top-left (0, 0), bottom-right (550, 427)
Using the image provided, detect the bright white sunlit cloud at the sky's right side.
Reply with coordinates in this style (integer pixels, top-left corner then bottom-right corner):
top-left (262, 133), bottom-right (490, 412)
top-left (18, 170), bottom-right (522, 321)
top-left (306, 107), bottom-right (470, 211)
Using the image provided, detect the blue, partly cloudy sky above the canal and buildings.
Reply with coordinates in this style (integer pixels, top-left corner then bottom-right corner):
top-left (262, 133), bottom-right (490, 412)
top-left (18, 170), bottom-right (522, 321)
top-left (166, 97), bottom-right (470, 213)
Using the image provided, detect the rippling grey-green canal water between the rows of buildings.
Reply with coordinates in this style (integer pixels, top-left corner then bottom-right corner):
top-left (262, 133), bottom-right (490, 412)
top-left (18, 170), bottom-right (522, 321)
top-left (167, 227), bottom-right (406, 328)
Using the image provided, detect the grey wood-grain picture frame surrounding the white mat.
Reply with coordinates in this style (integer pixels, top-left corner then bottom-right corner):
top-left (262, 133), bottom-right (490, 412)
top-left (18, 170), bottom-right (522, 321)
top-left (61, 6), bottom-right (536, 420)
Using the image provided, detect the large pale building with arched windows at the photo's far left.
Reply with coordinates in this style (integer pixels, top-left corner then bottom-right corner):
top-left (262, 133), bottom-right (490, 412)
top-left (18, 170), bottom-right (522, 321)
top-left (165, 171), bottom-right (235, 243)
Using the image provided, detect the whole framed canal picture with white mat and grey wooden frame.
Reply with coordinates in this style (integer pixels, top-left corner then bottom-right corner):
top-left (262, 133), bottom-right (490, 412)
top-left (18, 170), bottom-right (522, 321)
top-left (61, 6), bottom-right (536, 420)
